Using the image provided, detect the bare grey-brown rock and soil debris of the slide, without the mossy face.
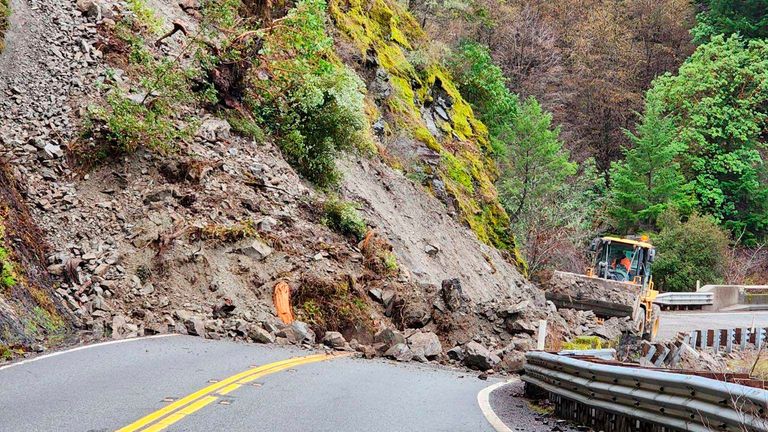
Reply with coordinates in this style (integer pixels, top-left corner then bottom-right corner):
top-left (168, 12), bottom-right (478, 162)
top-left (0, 0), bottom-right (615, 371)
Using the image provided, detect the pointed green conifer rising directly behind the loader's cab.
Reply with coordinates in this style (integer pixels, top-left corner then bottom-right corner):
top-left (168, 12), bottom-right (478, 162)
top-left (608, 99), bottom-right (695, 232)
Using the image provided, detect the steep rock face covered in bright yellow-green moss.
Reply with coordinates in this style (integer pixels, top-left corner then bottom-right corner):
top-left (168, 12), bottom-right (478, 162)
top-left (328, 0), bottom-right (525, 271)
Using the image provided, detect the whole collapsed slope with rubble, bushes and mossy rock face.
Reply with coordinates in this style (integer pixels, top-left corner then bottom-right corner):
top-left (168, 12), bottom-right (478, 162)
top-left (0, 0), bottom-right (592, 369)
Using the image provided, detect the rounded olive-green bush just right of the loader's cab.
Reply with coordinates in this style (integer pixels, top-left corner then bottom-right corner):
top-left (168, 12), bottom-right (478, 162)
top-left (653, 209), bottom-right (729, 291)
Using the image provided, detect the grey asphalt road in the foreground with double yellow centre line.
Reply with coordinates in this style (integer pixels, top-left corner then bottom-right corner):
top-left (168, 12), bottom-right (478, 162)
top-left (0, 336), bottom-right (527, 432)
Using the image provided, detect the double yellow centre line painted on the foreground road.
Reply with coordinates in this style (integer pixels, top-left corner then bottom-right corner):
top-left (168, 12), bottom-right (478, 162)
top-left (117, 354), bottom-right (337, 432)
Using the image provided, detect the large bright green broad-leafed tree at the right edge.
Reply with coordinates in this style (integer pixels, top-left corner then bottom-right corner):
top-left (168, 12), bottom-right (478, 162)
top-left (646, 35), bottom-right (768, 242)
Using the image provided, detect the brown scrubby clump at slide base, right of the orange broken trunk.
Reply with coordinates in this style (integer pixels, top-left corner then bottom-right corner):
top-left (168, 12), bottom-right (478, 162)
top-left (292, 274), bottom-right (372, 334)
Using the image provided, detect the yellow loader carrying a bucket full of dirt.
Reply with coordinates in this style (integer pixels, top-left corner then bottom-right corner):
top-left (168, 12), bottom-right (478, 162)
top-left (544, 236), bottom-right (661, 340)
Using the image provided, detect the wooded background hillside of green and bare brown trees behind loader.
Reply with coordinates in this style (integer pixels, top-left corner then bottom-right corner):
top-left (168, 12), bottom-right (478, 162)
top-left (411, 0), bottom-right (768, 290)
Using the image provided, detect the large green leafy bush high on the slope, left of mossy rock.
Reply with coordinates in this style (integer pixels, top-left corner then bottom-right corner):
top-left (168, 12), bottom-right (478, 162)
top-left (248, 0), bottom-right (368, 187)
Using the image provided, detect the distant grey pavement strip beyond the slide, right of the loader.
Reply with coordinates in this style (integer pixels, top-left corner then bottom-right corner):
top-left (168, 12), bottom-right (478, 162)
top-left (658, 311), bottom-right (768, 340)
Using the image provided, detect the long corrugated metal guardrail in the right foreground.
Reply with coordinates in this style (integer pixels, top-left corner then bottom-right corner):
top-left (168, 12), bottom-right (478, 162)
top-left (522, 351), bottom-right (768, 432)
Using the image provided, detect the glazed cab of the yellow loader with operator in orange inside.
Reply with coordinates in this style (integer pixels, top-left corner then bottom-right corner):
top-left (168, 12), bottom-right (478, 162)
top-left (590, 237), bottom-right (656, 286)
